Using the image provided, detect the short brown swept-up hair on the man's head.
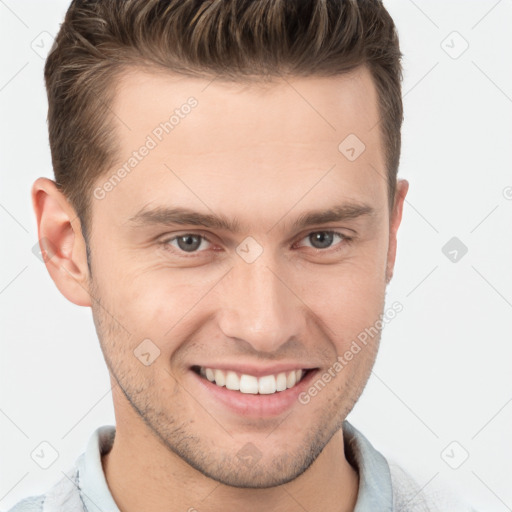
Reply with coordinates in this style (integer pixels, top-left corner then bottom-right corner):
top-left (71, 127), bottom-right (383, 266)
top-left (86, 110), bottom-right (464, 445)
top-left (45, 0), bottom-right (403, 241)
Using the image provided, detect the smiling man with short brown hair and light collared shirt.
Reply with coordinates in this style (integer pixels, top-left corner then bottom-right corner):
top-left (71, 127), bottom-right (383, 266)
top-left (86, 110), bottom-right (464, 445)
top-left (8, 0), bottom-right (474, 512)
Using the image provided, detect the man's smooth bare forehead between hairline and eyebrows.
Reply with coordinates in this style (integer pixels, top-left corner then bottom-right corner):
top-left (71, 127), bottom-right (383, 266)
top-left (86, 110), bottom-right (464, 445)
top-left (96, 67), bottom-right (386, 228)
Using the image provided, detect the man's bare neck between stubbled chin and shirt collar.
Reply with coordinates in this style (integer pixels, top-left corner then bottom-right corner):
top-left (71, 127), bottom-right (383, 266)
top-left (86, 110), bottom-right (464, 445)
top-left (102, 428), bottom-right (358, 512)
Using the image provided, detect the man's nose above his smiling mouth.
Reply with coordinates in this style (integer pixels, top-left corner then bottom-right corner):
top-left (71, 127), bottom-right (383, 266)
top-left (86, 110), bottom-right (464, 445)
top-left (218, 253), bottom-right (307, 352)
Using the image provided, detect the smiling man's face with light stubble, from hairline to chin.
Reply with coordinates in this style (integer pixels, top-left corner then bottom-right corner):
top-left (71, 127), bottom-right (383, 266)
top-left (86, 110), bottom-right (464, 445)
top-left (90, 69), bottom-right (404, 487)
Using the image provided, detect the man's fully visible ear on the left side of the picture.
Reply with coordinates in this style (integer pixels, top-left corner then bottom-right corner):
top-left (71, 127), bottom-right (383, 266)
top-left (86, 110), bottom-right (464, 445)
top-left (32, 178), bottom-right (91, 306)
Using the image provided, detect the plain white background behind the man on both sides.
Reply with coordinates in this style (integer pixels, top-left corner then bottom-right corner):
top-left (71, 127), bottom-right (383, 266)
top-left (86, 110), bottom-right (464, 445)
top-left (0, 0), bottom-right (512, 512)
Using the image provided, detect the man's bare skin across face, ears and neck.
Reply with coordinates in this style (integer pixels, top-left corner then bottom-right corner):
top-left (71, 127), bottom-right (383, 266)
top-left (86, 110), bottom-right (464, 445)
top-left (32, 67), bottom-right (409, 512)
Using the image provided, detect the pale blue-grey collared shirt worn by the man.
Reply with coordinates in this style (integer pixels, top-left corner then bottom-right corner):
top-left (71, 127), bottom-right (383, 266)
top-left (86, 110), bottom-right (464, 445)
top-left (9, 421), bottom-right (471, 512)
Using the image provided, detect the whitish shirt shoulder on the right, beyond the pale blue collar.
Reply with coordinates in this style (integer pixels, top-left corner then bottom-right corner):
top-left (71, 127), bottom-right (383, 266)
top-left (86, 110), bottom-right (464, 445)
top-left (388, 459), bottom-right (476, 512)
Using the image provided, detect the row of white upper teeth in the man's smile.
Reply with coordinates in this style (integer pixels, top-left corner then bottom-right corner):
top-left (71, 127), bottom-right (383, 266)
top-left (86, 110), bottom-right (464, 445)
top-left (200, 367), bottom-right (305, 395)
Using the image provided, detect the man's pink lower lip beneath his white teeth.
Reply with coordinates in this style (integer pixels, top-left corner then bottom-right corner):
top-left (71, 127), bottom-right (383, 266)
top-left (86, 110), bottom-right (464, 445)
top-left (190, 370), bottom-right (318, 418)
